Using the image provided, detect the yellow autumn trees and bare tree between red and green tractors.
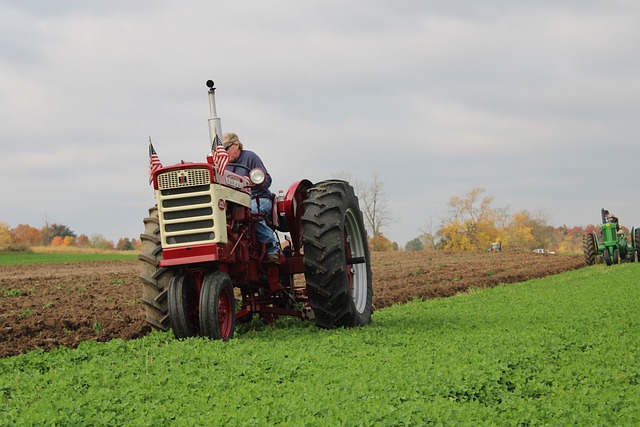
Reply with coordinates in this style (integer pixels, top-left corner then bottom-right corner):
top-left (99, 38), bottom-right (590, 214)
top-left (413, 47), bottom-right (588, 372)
top-left (348, 172), bottom-right (612, 252)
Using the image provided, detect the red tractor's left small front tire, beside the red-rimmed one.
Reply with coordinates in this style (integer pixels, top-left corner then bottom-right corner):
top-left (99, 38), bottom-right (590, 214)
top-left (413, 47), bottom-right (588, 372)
top-left (167, 276), bottom-right (199, 338)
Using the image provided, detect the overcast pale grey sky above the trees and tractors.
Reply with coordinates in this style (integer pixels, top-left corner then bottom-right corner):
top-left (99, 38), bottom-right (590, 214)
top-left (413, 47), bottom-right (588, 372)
top-left (0, 0), bottom-right (640, 245)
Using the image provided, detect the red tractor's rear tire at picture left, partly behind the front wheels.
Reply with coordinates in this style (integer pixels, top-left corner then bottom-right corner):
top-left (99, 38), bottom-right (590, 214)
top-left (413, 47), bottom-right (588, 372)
top-left (138, 206), bottom-right (176, 331)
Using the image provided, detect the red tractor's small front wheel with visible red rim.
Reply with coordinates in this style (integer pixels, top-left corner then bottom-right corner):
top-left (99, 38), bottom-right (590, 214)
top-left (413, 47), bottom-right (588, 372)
top-left (200, 271), bottom-right (236, 341)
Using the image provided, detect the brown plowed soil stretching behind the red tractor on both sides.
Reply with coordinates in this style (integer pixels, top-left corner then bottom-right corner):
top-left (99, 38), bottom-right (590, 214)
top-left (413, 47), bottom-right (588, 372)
top-left (0, 251), bottom-right (584, 357)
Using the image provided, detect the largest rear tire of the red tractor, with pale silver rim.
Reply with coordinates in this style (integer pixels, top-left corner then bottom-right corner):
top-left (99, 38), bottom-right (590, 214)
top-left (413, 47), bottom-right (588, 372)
top-left (302, 180), bottom-right (373, 328)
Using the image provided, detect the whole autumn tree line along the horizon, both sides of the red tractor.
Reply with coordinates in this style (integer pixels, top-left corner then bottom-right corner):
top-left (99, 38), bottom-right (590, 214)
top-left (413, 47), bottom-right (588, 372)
top-left (0, 185), bottom-right (608, 252)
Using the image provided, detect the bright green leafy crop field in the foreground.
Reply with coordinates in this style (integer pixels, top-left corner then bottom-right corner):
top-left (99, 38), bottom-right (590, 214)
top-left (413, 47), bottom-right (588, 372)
top-left (0, 264), bottom-right (640, 426)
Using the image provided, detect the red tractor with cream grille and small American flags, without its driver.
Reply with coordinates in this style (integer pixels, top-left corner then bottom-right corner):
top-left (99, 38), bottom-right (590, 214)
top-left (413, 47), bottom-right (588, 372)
top-left (139, 80), bottom-right (372, 340)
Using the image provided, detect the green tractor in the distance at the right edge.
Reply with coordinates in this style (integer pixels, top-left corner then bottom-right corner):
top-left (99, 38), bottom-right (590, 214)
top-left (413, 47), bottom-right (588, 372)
top-left (582, 209), bottom-right (640, 265)
